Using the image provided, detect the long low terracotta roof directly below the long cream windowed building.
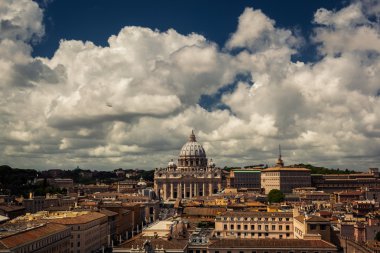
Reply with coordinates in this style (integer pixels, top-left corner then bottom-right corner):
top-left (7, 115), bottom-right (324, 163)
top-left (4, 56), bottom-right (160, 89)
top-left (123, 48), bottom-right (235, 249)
top-left (209, 239), bottom-right (336, 249)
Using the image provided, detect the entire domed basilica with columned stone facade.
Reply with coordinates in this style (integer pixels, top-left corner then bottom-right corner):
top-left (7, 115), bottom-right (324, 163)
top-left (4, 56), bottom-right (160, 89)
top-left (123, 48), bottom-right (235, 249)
top-left (154, 131), bottom-right (222, 201)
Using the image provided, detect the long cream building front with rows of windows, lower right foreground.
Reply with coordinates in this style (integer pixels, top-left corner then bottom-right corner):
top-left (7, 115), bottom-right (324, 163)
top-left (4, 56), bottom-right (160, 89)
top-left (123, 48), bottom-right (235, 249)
top-left (215, 211), bottom-right (294, 239)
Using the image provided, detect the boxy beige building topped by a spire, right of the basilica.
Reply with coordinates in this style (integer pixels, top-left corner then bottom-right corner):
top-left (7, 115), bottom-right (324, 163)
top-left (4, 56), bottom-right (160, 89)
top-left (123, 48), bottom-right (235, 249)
top-left (261, 155), bottom-right (311, 194)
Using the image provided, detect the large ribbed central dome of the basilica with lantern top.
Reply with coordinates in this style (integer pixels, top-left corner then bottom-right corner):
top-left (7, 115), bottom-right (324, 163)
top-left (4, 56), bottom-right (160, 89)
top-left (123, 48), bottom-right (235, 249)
top-left (178, 131), bottom-right (207, 167)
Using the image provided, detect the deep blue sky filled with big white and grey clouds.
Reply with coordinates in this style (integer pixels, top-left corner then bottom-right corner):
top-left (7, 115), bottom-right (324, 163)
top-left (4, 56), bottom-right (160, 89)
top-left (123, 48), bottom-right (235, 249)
top-left (0, 0), bottom-right (380, 170)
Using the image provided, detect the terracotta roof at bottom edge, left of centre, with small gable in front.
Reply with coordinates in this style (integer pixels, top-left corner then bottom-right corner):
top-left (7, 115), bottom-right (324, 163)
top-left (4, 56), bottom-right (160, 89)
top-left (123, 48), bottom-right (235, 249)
top-left (115, 236), bottom-right (188, 250)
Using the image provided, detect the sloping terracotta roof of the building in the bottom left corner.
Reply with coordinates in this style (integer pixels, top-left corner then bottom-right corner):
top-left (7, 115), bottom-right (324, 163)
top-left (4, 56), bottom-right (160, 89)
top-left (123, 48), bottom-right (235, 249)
top-left (0, 223), bottom-right (70, 249)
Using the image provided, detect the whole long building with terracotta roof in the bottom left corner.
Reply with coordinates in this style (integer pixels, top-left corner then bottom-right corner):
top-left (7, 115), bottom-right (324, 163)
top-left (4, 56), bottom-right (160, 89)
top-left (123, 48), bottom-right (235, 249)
top-left (0, 222), bottom-right (70, 253)
